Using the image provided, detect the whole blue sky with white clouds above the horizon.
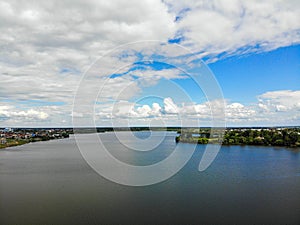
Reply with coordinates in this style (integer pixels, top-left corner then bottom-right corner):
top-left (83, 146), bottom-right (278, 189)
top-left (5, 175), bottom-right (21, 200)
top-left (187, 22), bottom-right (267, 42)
top-left (0, 0), bottom-right (300, 127)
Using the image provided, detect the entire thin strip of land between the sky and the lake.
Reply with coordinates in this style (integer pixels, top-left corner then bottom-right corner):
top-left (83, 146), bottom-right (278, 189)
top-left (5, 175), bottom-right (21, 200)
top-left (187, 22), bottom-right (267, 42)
top-left (0, 127), bottom-right (300, 149)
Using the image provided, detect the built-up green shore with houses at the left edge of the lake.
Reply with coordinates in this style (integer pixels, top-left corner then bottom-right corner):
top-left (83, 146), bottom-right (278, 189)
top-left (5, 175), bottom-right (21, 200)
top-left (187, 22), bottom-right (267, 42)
top-left (0, 128), bottom-right (73, 149)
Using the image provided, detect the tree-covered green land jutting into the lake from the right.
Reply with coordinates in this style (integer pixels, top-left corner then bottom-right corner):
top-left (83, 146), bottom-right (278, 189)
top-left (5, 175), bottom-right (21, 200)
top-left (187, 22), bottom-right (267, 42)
top-left (176, 127), bottom-right (300, 147)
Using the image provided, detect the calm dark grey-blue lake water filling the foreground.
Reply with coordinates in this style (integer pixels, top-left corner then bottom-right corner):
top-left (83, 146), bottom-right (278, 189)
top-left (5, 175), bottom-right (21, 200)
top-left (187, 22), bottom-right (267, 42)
top-left (0, 133), bottom-right (300, 224)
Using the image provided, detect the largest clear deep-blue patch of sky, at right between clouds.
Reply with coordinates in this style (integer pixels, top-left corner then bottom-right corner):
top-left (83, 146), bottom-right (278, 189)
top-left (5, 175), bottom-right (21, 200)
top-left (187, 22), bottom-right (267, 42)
top-left (209, 45), bottom-right (300, 104)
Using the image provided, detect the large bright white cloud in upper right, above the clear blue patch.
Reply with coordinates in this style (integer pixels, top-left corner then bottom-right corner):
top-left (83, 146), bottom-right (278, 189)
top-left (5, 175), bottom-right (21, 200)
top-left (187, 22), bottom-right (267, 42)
top-left (166, 0), bottom-right (300, 59)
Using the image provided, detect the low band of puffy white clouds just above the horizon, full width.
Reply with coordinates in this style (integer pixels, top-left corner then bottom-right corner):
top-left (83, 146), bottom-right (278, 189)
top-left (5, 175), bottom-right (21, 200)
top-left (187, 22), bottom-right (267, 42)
top-left (0, 90), bottom-right (300, 126)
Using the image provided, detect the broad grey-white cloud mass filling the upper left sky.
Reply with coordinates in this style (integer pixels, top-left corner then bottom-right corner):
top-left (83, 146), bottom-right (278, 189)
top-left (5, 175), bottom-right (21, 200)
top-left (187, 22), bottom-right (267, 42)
top-left (0, 0), bottom-right (175, 106)
